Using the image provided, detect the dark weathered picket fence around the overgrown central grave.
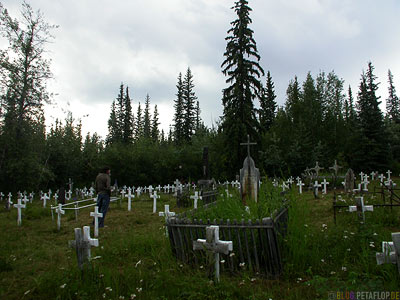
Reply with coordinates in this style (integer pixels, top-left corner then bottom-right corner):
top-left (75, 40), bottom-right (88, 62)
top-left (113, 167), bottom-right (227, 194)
top-left (166, 208), bottom-right (288, 278)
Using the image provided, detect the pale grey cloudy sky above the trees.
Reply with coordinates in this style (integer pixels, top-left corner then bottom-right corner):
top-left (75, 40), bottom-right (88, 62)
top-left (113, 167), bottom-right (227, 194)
top-left (0, 0), bottom-right (400, 137)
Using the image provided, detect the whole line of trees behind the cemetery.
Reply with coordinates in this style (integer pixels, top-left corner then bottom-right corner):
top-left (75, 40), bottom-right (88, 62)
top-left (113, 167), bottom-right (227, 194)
top-left (0, 0), bottom-right (400, 191)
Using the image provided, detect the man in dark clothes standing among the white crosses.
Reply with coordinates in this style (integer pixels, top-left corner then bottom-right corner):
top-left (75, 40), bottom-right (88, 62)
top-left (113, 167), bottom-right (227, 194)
top-left (96, 167), bottom-right (111, 227)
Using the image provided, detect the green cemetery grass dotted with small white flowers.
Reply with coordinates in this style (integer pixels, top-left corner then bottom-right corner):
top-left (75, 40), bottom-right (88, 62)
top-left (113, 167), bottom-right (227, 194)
top-left (0, 182), bottom-right (400, 299)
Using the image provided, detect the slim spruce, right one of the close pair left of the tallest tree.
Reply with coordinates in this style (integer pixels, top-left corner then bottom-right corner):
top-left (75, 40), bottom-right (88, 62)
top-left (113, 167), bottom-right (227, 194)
top-left (182, 68), bottom-right (197, 142)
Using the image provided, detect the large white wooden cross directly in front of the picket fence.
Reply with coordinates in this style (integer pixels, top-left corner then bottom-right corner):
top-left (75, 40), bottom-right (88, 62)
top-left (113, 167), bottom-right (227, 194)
top-left (193, 225), bottom-right (233, 282)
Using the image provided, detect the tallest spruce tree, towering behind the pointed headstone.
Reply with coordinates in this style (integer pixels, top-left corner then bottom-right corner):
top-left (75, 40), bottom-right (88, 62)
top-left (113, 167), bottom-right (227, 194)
top-left (221, 0), bottom-right (264, 172)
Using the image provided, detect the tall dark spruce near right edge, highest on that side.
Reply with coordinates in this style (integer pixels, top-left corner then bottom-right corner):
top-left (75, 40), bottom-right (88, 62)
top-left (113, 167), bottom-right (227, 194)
top-left (357, 62), bottom-right (387, 171)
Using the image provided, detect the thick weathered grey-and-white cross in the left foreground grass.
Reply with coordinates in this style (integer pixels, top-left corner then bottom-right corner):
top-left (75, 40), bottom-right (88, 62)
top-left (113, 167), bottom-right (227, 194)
top-left (69, 226), bottom-right (99, 270)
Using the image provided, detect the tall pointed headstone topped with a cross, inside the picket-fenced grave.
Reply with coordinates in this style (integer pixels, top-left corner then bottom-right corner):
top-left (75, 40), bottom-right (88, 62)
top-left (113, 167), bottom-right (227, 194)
top-left (240, 135), bottom-right (260, 205)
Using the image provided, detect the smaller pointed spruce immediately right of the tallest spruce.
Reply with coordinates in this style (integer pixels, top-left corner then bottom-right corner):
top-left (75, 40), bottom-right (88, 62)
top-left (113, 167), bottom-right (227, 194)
top-left (259, 71), bottom-right (276, 132)
